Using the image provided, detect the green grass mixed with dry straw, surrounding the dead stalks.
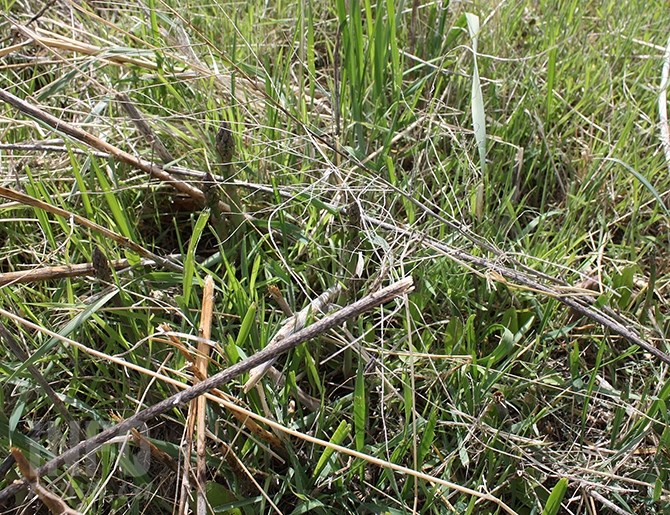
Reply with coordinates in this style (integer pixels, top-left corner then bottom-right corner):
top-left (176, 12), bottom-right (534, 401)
top-left (0, 0), bottom-right (670, 514)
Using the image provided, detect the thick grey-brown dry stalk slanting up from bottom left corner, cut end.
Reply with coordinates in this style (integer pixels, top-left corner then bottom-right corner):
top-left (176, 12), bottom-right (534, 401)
top-left (0, 277), bottom-right (414, 504)
